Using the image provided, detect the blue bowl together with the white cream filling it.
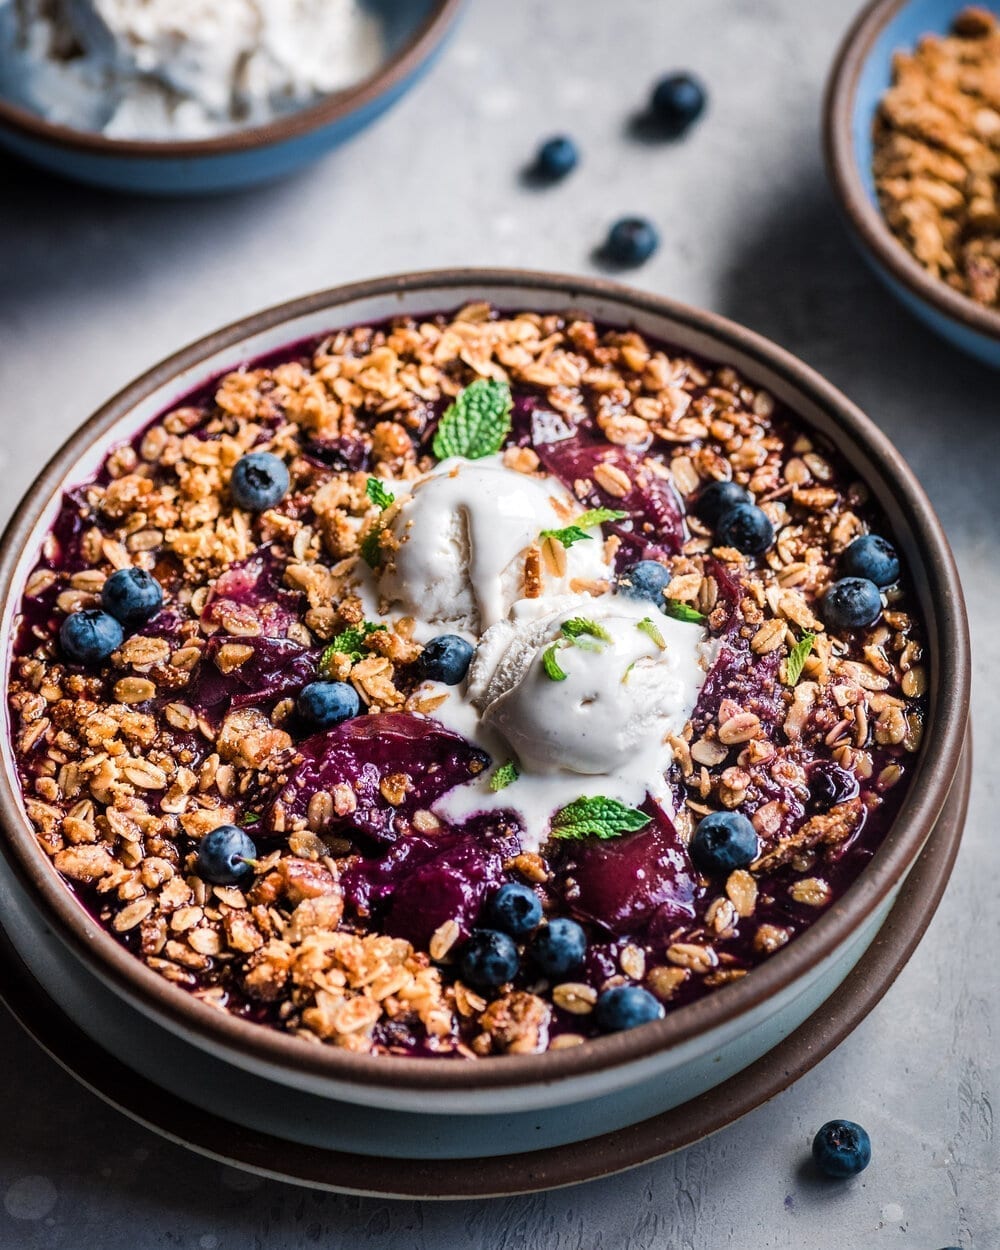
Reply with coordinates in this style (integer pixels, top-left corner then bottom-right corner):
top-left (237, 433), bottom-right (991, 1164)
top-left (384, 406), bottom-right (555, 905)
top-left (0, 0), bottom-right (461, 195)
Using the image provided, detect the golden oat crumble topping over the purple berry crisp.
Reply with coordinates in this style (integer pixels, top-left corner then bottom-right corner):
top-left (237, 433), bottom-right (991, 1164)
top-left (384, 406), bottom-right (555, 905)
top-left (10, 302), bottom-right (930, 1058)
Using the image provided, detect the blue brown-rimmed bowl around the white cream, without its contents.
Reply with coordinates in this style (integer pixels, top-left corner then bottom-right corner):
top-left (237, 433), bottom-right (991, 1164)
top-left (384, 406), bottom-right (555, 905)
top-left (0, 0), bottom-right (461, 195)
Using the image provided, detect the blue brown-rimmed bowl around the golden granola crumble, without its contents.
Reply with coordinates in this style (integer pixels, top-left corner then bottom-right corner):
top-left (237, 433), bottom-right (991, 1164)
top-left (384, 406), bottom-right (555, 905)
top-left (824, 0), bottom-right (1000, 369)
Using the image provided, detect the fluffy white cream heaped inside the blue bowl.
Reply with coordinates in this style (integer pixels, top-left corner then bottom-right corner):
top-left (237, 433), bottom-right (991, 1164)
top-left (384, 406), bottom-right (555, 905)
top-left (0, 0), bottom-right (384, 140)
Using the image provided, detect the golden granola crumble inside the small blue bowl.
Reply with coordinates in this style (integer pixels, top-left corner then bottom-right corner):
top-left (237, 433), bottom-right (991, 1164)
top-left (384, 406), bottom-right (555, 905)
top-left (874, 8), bottom-right (1000, 308)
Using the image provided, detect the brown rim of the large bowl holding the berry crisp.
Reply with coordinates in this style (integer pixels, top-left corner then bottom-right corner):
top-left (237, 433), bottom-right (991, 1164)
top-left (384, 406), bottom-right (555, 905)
top-left (0, 269), bottom-right (971, 1093)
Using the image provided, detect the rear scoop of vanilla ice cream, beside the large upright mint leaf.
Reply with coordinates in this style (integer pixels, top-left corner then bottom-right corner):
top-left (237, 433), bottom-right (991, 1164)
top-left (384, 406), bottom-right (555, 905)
top-left (379, 456), bottom-right (611, 636)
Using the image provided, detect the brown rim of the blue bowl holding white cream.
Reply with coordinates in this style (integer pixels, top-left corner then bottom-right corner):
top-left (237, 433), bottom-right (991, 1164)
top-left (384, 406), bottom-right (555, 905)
top-left (0, 0), bottom-right (464, 160)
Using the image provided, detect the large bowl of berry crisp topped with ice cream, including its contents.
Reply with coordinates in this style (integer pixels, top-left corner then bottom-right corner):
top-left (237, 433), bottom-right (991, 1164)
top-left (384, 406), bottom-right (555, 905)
top-left (0, 270), bottom-right (970, 1158)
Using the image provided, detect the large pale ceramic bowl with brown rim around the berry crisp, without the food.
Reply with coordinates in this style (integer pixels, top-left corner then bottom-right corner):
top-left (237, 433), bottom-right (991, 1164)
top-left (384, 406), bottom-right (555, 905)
top-left (0, 270), bottom-right (970, 1151)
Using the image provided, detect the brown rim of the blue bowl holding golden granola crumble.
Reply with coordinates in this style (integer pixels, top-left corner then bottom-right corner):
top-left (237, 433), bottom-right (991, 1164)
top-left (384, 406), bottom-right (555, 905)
top-left (823, 0), bottom-right (1000, 340)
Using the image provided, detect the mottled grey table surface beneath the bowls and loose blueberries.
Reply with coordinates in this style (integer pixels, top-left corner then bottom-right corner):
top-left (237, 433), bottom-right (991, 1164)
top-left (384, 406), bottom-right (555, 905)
top-left (0, 0), bottom-right (1000, 1250)
